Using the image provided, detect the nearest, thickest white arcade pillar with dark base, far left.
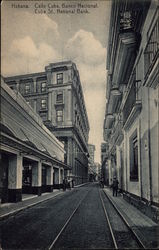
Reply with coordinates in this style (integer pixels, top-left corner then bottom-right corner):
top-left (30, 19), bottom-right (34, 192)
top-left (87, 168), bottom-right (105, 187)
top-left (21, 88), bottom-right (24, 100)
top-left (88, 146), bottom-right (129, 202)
top-left (8, 155), bottom-right (22, 202)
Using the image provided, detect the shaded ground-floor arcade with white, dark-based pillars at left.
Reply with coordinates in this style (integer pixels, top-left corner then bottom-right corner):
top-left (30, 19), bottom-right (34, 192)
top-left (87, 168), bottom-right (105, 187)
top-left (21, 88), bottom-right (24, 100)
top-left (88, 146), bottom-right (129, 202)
top-left (0, 148), bottom-right (64, 203)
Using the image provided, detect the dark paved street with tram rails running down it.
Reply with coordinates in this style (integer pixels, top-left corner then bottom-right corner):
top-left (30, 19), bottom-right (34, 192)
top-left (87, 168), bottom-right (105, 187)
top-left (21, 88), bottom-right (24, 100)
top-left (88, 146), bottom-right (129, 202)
top-left (0, 183), bottom-right (157, 249)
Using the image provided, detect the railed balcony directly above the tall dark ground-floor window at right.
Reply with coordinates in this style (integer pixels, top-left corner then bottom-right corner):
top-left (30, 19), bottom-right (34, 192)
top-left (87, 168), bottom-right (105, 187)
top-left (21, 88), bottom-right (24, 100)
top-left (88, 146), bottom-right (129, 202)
top-left (123, 76), bottom-right (142, 129)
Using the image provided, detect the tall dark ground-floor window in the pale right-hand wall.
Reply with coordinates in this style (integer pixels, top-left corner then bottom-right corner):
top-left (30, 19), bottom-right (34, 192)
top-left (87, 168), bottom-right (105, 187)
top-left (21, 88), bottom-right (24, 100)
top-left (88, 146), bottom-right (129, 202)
top-left (130, 133), bottom-right (138, 181)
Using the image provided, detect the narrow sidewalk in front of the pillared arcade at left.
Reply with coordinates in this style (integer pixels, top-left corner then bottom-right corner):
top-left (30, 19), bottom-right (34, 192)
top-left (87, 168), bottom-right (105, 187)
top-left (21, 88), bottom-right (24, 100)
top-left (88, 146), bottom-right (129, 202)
top-left (0, 183), bottom-right (88, 220)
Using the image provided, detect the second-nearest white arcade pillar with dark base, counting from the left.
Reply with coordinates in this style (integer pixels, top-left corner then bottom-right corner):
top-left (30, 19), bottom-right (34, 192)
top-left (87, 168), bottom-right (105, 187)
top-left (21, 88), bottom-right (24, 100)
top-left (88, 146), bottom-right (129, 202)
top-left (32, 161), bottom-right (42, 196)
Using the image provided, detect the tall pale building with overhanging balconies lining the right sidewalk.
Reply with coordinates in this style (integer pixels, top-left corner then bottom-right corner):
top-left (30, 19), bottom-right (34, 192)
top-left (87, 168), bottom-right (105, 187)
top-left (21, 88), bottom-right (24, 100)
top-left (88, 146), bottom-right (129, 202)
top-left (104, 0), bottom-right (159, 222)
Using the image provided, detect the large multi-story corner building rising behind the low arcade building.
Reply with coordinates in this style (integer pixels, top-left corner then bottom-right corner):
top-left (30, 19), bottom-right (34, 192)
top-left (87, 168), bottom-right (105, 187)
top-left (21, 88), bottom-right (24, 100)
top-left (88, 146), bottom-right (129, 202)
top-left (5, 61), bottom-right (89, 184)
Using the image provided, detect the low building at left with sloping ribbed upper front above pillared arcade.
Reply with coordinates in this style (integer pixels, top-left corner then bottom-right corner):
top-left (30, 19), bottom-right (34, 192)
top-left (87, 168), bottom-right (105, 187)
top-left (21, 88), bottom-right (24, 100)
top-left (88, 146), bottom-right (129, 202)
top-left (0, 78), bottom-right (70, 203)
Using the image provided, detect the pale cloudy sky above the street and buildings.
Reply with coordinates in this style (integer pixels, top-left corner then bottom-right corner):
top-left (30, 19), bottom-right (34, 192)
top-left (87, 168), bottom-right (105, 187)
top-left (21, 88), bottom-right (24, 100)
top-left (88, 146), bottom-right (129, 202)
top-left (1, 0), bottom-right (111, 163)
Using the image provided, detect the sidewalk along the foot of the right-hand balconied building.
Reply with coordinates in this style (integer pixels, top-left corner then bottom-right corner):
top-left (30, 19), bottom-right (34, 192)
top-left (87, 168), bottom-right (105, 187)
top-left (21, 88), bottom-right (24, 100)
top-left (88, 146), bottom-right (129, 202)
top-left (103, 188), bottom-right (159, 249)
